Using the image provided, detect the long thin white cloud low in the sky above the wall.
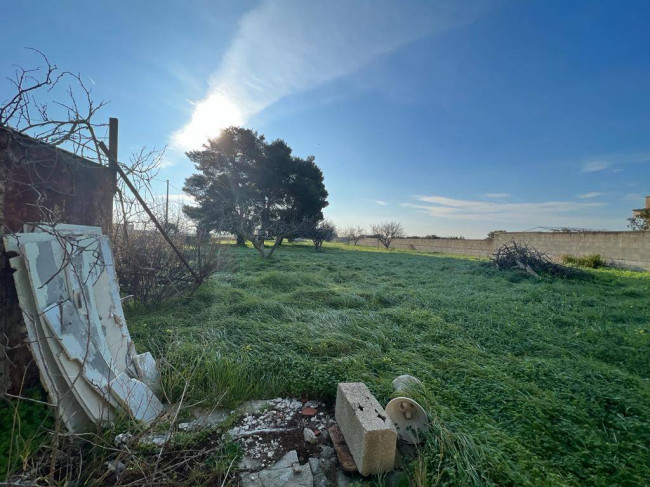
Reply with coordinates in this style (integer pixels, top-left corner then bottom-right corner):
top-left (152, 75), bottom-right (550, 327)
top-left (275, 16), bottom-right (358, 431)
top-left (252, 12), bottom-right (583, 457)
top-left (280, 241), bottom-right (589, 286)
top-left (402, 195), bottom-right (606, 226)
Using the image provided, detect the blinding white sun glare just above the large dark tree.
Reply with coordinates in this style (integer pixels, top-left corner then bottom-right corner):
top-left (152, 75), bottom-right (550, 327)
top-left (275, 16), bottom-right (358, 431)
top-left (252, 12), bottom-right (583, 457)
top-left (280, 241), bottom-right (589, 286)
top-left (174, 93), bottom-right (244, 150)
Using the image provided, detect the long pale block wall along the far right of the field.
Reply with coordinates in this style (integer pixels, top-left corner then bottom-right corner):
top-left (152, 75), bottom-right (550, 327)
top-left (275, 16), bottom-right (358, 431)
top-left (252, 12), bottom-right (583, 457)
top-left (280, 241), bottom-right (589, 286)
top-left (359, 232), bottom-right (650, 271)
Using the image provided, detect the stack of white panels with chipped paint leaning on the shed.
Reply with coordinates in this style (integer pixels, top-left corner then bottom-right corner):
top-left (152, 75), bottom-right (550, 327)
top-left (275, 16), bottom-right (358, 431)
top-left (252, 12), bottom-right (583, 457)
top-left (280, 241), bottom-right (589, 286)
top-left (4, 225), bottom-right (162, 432)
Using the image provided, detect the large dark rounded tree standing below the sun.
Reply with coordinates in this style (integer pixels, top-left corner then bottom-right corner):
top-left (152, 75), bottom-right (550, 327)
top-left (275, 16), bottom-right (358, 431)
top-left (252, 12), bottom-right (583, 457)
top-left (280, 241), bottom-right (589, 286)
top-left (183, 127), bottom-right (328, 256)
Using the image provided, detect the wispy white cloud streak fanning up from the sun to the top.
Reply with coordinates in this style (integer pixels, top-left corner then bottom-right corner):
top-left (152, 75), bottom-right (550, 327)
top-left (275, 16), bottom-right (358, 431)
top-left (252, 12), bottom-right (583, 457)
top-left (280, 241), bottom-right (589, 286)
top-left (172, 0), bottom-right (486, 149)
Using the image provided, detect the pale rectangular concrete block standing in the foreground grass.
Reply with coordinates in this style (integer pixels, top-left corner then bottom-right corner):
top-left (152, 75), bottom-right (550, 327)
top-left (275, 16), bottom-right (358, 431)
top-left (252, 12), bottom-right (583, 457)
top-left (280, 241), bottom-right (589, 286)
top-left (335, 382), bottom-right (397, 475)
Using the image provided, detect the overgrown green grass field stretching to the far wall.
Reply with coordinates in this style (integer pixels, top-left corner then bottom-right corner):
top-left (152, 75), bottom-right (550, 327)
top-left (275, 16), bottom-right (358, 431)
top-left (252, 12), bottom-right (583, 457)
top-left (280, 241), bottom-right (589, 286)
top-left (123, 244), bottom-right (650, 486)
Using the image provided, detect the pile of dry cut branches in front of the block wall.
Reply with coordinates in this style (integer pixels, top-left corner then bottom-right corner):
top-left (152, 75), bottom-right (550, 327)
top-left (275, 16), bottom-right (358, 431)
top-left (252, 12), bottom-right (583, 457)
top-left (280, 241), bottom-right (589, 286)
top-left (491, 240), bottom-right (580, 279)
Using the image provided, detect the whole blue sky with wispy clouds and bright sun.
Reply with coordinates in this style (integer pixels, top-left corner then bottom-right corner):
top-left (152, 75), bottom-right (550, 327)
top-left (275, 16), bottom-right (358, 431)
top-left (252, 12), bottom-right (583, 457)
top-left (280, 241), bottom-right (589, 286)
top-left (0, 0), bottom-right (650, 237)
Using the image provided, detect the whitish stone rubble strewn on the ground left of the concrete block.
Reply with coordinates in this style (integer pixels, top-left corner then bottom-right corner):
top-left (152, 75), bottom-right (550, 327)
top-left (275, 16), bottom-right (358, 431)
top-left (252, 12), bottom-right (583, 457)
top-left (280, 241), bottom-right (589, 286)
top-left (106, 398), bottom-right (370, 487)
